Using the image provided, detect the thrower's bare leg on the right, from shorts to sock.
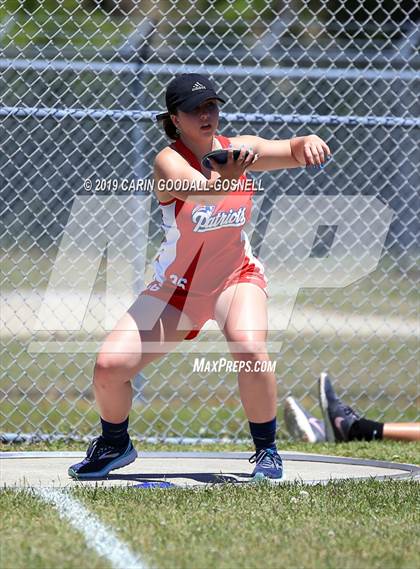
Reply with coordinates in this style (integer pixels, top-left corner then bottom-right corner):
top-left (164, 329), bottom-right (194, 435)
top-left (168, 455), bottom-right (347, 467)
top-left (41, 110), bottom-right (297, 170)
top-left (215, 283), bottom-right (277, 423)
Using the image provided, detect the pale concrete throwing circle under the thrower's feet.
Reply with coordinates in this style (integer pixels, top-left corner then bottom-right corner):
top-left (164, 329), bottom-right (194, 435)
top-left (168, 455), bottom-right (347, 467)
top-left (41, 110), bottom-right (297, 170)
top-left (0, 452), bottom-right (420, 488)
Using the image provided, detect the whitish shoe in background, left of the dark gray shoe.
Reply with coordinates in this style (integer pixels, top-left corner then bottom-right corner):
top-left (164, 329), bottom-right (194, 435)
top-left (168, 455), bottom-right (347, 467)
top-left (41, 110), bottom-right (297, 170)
top-left (284, 397), bottom-right (327, 443)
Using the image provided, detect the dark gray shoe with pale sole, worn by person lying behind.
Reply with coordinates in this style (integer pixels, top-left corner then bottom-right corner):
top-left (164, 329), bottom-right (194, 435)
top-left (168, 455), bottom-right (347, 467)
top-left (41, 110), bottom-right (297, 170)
top-left (319, 372), bottom-right (360, 443)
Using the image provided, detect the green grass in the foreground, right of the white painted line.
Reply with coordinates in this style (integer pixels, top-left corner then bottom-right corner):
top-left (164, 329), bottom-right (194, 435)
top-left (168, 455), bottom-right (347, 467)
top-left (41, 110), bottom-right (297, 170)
top-left (79, 483), bottom-right (420, 569)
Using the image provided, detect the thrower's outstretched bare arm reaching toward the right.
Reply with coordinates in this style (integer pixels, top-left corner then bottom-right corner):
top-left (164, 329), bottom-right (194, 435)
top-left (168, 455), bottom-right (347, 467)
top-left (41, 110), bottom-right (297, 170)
top-left (230, 134), bottom-right (331, 172)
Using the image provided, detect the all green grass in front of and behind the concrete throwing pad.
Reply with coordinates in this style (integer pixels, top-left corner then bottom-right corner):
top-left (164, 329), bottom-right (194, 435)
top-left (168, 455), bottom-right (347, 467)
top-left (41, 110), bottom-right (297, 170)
top-left (0, 442), bottom-right (420, 569)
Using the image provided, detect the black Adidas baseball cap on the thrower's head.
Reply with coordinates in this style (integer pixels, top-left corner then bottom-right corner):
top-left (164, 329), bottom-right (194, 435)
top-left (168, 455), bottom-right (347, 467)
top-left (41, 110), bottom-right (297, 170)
top-left (156, 73), bottom-right (225, 120)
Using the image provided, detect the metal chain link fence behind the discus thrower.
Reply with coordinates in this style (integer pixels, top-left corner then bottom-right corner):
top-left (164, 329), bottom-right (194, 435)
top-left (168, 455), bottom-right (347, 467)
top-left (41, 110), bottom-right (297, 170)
top-left (0, 0), bottom-right (420, 440)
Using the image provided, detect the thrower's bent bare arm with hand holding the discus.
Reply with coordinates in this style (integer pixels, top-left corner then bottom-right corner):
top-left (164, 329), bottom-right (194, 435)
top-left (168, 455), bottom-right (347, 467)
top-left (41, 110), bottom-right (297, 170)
top-left (154, 147), bottom-right (253, 204)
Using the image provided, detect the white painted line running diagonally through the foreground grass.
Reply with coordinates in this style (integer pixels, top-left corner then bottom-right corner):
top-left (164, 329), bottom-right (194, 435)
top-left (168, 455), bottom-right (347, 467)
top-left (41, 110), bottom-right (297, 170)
top-left (33, 488), bottom-right (146, 569)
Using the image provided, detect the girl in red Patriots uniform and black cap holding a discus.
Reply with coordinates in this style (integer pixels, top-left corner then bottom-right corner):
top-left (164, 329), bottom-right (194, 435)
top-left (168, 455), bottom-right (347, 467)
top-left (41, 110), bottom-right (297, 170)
top-left (69, 74), bottom-right (330, 480)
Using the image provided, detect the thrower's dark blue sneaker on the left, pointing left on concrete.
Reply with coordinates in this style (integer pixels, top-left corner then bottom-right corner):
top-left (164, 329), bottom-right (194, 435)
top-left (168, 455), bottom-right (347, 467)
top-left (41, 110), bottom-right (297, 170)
top-left (68, 436), bottom-right (137, 480)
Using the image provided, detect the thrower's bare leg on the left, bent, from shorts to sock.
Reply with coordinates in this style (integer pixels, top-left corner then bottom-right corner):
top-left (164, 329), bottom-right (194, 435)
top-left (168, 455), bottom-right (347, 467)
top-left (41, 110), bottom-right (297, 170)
top-left (93, 295), bottom-right (192, 423)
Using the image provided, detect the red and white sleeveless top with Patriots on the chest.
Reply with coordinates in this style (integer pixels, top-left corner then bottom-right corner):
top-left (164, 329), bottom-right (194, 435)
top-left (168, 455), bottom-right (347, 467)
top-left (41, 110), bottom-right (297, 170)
top-left (148, 131), bottom-right (264, 296)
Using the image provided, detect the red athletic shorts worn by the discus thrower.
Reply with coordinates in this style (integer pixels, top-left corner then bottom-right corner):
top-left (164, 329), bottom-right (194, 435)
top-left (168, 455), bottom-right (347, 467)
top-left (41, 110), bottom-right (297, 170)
top-left (139, 262), bottom-right (268, 340)
